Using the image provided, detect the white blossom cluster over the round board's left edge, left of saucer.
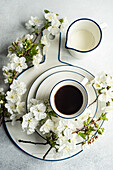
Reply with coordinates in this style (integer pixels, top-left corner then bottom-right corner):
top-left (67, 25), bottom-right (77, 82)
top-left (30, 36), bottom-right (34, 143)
top-left (5, 80), bottom-right (26, 124)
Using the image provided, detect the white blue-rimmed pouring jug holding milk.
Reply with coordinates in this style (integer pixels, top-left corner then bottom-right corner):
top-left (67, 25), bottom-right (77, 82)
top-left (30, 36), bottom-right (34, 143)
top-left (65, 18), bottom-right (106, 58)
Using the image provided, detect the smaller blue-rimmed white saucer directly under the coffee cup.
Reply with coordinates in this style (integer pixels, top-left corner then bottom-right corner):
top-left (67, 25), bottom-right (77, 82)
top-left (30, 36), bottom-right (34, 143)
top-left (35, 70), bottom-right (98, 117)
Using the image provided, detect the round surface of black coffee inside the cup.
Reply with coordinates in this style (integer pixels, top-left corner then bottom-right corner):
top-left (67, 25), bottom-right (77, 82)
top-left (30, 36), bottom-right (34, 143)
top-left (55, 85), bottom-right (83, 115)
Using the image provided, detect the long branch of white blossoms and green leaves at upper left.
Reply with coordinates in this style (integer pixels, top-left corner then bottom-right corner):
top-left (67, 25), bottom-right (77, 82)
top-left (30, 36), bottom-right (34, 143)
top-left (3, 10), bottom-right (67, 84)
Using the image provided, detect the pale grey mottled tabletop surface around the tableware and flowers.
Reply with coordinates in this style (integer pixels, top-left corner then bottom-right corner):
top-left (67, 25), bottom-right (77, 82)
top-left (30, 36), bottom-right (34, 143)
top-left (0, 0), bottom-right (113, 170)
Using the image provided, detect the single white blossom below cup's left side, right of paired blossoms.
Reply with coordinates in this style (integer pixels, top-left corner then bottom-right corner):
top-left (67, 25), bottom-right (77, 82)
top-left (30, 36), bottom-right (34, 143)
top-left (40, 119), bottom-right (54, 134)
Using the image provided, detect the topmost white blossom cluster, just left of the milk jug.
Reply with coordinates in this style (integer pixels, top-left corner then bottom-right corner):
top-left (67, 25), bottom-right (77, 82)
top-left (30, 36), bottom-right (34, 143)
top-left (25, 10), bottom-right (68, 55)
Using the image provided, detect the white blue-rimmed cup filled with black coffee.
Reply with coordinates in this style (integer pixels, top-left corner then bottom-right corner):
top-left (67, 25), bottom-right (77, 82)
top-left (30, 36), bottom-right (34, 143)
top-left (50, 78), bottom-right (88, 119)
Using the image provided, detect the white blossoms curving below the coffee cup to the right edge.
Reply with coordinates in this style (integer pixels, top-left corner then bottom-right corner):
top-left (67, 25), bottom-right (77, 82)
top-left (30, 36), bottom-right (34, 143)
top-left (22, 73), bottom-right (113, 155)
